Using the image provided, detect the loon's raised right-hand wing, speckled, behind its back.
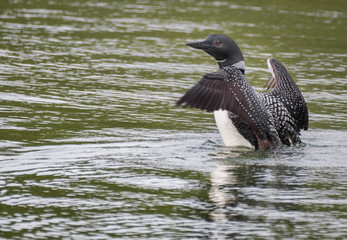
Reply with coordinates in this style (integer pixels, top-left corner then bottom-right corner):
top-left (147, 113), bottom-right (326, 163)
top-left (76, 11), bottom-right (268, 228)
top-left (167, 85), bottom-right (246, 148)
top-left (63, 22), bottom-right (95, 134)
top-left (264, 58), bottom-right (308, 130)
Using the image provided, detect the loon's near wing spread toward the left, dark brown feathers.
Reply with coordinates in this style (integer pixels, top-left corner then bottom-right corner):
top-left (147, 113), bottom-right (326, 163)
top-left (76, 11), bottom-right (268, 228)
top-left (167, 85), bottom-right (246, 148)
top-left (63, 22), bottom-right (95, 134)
top-left (176, 66), bottom-right (278, 148)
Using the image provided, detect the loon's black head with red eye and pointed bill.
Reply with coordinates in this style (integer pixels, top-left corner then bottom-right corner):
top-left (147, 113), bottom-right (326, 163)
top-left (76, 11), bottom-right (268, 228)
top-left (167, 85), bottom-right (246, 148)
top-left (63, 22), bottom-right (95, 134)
top-left (187, 34), bottom-right (244, 67)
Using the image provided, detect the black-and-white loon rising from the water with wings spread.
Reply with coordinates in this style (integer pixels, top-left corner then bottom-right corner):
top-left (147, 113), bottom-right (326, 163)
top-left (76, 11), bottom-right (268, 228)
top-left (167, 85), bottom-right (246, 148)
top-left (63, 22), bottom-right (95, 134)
top-left (176, 34), bottom-right (308, 150)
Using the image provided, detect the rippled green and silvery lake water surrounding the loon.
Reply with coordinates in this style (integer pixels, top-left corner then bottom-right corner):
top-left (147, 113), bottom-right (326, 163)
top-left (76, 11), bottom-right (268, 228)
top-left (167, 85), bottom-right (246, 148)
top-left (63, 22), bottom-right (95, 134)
top-left (0, 0), bottom-right (347, 239)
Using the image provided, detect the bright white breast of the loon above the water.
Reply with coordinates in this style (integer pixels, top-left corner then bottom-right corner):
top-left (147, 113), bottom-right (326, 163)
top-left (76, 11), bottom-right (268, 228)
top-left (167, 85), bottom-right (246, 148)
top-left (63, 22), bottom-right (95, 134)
top-left (213, 110), bottom-right (252, 148)
